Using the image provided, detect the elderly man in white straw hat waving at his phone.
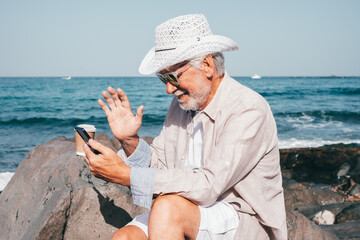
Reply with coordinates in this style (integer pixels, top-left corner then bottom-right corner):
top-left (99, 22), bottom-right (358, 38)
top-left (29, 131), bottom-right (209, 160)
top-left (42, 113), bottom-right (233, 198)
top-left (85, 14), bottom-right (287, 239)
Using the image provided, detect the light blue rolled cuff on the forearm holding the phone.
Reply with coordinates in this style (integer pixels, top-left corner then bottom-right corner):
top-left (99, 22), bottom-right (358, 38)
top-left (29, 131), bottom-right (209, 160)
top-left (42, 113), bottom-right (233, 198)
top-left (130, 167), bottom-right (156, 209)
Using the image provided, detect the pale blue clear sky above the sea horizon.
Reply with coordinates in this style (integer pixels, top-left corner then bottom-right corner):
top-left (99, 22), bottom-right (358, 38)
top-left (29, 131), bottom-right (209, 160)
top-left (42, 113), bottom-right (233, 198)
top-left (0, 0), bottom-right (360, 76)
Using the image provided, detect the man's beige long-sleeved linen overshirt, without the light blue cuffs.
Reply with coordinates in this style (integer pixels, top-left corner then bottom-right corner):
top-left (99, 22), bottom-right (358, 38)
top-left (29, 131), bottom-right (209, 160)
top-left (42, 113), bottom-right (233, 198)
top-left (151, 74), bottom-right (287, 239)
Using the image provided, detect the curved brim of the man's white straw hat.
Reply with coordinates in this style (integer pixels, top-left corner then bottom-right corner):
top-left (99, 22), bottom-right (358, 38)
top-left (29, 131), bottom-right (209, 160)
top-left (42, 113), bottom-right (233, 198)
top-left (139, 35), bottom-right (239, 75)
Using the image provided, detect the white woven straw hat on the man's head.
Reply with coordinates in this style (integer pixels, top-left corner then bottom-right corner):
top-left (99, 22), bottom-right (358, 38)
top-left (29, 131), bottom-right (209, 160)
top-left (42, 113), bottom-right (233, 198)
top-left (139, 14), bottom-right (238, 74)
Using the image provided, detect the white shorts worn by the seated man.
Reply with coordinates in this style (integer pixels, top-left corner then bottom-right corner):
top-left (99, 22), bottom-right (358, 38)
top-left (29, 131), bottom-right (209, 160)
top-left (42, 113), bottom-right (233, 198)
top-left (127, 202), bottom-right (239, 240)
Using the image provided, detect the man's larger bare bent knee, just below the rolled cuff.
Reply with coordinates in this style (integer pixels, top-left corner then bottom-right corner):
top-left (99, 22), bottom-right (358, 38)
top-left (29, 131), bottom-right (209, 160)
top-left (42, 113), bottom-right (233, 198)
top-left (149, 195), bottom-right (200, 240)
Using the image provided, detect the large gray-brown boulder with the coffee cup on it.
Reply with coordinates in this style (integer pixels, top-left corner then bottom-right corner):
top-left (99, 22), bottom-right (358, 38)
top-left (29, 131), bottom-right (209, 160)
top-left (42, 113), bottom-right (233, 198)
top-left (0, 134), bottom-right (145, 240)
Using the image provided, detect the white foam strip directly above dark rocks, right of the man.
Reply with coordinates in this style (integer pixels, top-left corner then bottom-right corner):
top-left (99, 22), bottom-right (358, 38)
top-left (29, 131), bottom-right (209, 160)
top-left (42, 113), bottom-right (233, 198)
top-left (279, 138), bottom-right (360, 149)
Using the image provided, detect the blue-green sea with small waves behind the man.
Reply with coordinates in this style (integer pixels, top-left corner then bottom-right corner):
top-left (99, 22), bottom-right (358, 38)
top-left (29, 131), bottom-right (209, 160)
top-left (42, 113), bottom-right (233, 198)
top-left (0, 76), bottom-right (360, 191)
